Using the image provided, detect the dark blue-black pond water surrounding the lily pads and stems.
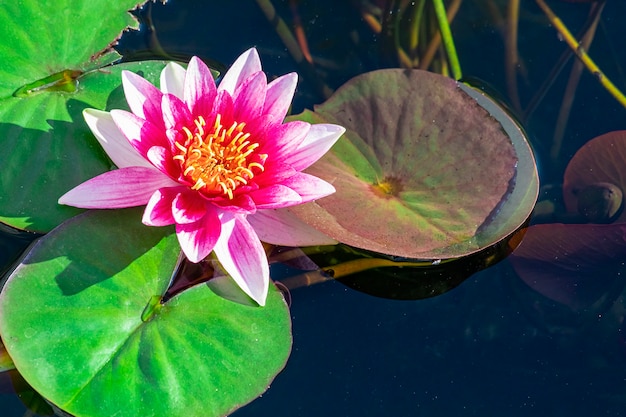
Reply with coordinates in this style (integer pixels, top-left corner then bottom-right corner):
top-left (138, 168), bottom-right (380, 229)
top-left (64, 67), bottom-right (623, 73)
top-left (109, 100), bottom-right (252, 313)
top-left (0, 0), bottom-right (626, 417)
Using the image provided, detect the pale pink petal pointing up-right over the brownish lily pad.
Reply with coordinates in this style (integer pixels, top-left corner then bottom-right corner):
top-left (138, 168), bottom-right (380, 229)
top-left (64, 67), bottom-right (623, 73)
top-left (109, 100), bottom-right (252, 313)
top-left (285, 123), bottom-right (346, 171)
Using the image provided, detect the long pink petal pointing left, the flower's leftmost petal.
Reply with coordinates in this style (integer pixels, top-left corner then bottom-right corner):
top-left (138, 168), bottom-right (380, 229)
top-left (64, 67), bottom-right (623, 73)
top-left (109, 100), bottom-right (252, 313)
top-left (59, 167), bottom-right (178, 209)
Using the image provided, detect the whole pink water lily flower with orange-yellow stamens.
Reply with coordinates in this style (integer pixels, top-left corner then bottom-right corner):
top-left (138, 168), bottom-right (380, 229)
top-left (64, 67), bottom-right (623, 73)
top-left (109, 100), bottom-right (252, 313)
top-left (59, 49), bottom-right (344, 305)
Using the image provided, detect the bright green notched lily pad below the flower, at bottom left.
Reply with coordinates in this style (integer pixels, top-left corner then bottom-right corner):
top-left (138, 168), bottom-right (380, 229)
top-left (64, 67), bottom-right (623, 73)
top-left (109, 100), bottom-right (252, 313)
top-left (0, 209), bottom-right (291, 417)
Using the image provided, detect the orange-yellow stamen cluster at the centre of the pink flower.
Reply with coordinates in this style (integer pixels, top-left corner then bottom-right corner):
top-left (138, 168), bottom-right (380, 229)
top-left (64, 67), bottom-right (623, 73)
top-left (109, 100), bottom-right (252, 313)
top-left (174, 114), bottom-right (267, 199)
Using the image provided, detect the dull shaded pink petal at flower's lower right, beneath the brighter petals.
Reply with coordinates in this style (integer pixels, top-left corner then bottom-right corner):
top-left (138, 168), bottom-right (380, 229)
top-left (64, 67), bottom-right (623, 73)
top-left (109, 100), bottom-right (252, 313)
top-left (247, 209), bottom-right (337, 246)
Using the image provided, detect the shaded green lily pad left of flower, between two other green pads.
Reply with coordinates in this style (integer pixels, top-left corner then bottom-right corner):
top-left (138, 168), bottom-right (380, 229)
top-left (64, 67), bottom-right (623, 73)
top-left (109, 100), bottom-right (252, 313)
top-left (0, 61), bottom-right (164, 233)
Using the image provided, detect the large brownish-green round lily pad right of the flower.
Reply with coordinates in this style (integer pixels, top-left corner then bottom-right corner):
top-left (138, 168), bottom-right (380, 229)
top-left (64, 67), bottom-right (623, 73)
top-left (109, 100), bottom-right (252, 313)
top-left (290, 69), bottom-right (539, 259)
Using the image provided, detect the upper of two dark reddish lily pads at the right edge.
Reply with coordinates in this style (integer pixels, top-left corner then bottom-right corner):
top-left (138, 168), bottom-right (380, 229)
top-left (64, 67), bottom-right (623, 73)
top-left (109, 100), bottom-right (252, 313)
top-left (563, 130), bottom-right (626, 223)
